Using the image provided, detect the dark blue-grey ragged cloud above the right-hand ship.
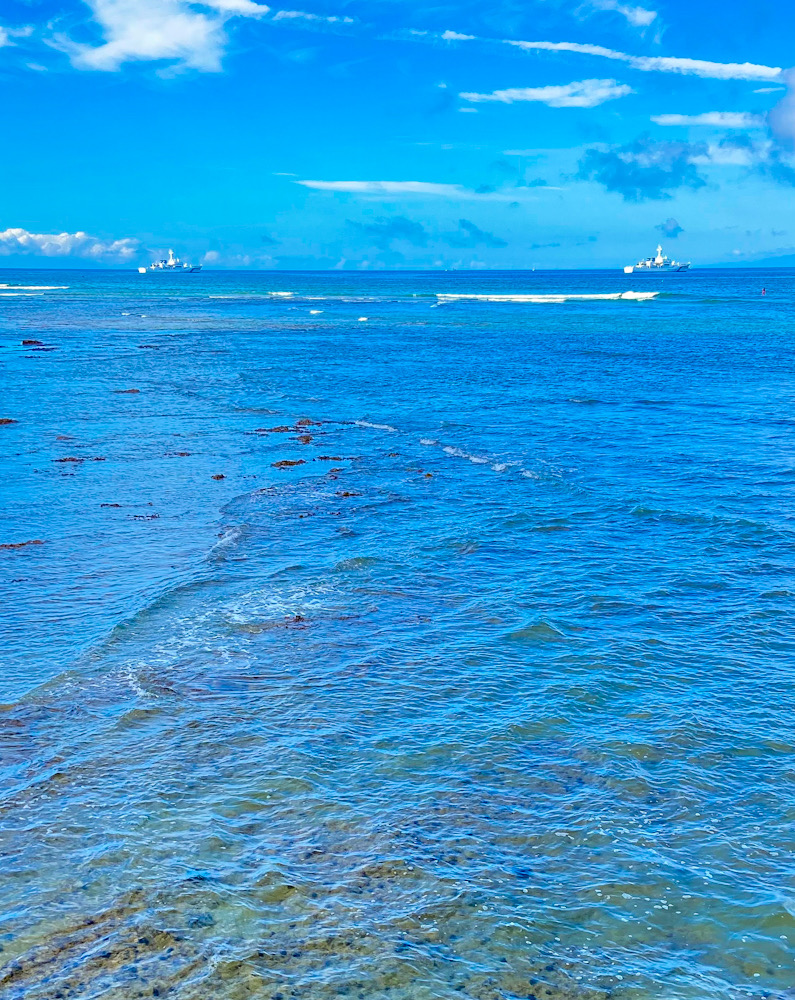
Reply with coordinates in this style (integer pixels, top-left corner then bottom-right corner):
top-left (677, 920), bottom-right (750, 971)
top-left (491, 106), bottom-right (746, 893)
top-left (578, 137), bottom-right (707, 201)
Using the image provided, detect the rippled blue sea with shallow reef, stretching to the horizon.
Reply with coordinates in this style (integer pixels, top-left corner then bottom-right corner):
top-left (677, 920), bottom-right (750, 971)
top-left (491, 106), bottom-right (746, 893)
top-left (0, 271), bottom-right (795, 1000)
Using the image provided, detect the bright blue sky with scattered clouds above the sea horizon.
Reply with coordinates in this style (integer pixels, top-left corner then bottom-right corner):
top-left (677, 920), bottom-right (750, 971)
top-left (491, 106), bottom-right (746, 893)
top-left (0, 0), bottom-right (795, 269)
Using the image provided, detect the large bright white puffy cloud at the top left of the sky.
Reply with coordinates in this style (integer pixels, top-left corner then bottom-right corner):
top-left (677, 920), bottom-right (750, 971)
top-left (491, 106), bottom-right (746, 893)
top-left (59, 0), bottom-right (269, 72)
